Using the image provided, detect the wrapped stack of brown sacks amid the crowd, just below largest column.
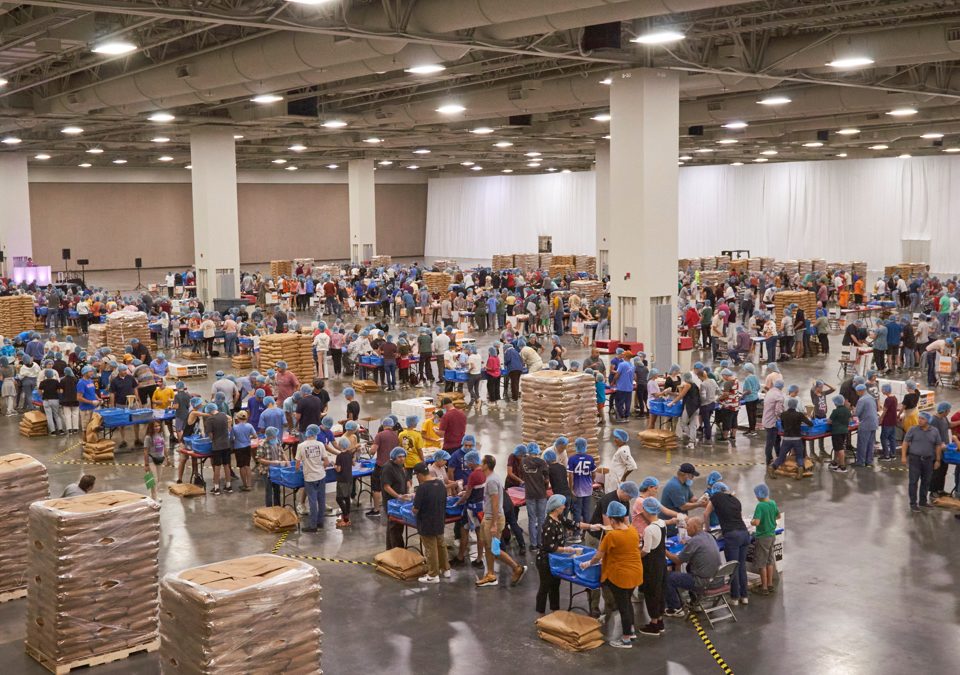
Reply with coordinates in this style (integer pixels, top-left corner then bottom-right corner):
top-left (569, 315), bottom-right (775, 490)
top-left (520, 370), bottom-right (598, 455)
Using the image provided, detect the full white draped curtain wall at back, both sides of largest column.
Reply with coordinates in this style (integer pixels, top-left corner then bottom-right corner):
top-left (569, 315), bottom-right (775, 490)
top-left (425, 156), bottom-right (960, 272)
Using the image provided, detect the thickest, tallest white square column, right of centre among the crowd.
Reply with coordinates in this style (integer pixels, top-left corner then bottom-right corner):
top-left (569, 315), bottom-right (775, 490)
top-left (609, 68), bottom-right (680, 368)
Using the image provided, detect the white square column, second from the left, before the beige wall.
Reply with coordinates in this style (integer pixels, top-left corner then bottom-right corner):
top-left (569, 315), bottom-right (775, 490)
top-left (190, 127), bottom-right (240, 309)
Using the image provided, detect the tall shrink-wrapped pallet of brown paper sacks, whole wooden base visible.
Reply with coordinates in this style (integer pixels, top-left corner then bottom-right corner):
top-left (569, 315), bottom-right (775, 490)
top-left (27, 490), bottom-right (160, 672)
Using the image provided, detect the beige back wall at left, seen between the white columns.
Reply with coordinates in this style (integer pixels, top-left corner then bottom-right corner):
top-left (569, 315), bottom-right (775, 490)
top-left (30, 182), bottom-right (427, 270)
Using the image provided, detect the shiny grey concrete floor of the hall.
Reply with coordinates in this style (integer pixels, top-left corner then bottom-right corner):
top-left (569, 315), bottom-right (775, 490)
top-left (0, 320), bottom-right (960, 675)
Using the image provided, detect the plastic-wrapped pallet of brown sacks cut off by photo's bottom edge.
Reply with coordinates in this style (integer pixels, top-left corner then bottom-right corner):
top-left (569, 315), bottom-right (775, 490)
top-left (160, 555), bottom-right (323, 675)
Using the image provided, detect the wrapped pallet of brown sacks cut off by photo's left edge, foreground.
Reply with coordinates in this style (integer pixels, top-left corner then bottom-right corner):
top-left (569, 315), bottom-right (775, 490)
top-left (0, 452), bottom-right (50, 602)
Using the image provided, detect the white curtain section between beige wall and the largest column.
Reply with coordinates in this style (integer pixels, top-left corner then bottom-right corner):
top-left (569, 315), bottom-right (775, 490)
top-left (424, 172), bottom-right (597, 258)
